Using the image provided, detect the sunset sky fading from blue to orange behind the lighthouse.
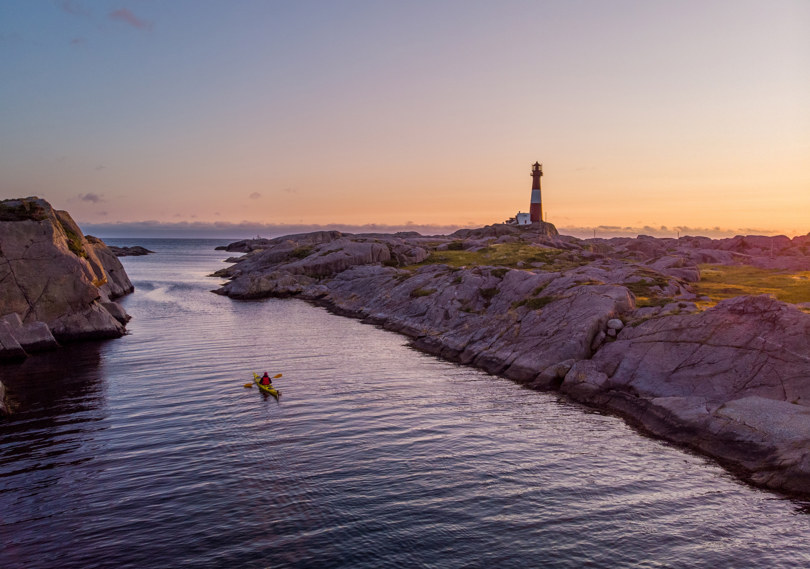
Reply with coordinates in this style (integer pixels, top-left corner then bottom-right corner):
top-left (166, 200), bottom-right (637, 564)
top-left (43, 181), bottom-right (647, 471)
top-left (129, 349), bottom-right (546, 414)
top-left (0, 0), bottom-right (810, 237)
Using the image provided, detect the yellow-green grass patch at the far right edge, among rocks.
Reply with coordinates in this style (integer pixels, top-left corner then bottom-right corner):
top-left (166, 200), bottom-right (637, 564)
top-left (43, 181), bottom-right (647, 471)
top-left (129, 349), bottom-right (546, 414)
top-left (693, 265), bottom-right (810, 305)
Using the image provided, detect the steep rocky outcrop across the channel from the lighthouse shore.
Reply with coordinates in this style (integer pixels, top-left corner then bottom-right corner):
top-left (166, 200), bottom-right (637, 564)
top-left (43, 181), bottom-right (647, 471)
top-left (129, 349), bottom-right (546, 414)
top-left (0, 198), bottom-right (133, 358)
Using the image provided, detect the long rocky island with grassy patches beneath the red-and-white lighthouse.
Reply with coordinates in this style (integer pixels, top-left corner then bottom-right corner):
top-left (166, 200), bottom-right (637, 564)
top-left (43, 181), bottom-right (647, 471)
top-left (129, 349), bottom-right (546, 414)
top-left (214, 223), bottom-right (810, 494)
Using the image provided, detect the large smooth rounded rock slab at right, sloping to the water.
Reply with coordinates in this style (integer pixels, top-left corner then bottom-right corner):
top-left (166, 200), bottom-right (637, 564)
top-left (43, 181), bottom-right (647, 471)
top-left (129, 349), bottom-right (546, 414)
top-left (561, 296), bottom-right (810, 492)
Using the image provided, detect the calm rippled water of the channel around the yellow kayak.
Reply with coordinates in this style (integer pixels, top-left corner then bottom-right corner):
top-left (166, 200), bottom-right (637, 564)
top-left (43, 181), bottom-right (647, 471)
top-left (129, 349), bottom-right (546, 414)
top-left (0, 240), bottom-right (810, 569)
